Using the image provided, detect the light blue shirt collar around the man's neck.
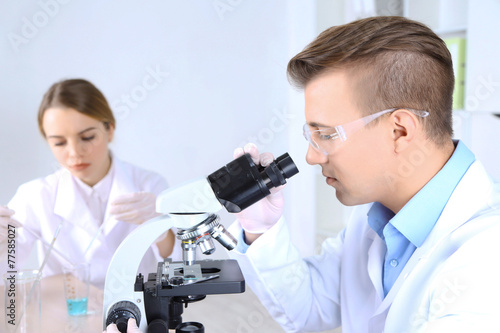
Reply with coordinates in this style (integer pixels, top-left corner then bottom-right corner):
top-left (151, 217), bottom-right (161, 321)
top-left (368, 141), bottom-right (475, 247)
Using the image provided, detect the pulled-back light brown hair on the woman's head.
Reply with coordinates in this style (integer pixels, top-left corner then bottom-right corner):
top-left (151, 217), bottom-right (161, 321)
top-left (38, 79), bottom-right (116, 137)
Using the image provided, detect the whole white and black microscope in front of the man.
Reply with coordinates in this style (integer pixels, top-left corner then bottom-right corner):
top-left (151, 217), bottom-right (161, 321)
top-left (103, 153), bottom-right (299, 333)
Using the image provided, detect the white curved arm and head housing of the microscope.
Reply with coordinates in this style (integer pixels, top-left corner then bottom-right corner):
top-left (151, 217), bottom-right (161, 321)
top-left (103, 178), bottom-right (223, 332)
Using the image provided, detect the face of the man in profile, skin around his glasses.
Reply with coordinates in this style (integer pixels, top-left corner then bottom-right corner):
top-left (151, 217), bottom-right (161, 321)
top-left (304, 71), bottom-right (394, 206)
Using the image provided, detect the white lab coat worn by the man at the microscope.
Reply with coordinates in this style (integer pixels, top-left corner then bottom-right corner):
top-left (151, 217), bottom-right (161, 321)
top-left (230, 161), bottom-right (500, 333)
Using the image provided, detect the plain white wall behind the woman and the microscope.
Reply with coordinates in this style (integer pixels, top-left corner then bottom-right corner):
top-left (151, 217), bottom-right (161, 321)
top-left (0, 0), bottom-right (315, 253)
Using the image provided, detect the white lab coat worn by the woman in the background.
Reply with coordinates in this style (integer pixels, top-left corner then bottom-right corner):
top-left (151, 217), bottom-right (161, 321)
top-left (4, 158), bottom-right (174, 288)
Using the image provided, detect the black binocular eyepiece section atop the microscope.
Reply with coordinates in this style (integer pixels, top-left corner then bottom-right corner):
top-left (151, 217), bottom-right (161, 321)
top-left (207, 153), bottom-right (299, 213)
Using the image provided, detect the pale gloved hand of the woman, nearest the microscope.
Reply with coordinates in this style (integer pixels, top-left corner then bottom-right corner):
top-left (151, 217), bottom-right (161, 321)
top-left (109, 192), bottom-right (160, 224)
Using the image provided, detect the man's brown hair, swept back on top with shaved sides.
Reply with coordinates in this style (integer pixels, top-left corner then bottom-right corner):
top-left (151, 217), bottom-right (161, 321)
top-left (287, 16), bottom-right (454, 145)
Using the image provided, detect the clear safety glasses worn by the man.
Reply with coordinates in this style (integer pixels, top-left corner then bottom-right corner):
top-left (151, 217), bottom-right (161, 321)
top-left (303, 108), bottom-right (429, 155)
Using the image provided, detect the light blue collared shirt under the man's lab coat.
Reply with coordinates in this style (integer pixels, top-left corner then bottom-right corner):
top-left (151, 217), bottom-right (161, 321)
top-left (368, 141), bottom-right (475, 296)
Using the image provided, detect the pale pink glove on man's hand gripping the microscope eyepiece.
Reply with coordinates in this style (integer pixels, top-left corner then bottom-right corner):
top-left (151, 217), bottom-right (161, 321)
top-left (233, 143), bottom-right (285, 234)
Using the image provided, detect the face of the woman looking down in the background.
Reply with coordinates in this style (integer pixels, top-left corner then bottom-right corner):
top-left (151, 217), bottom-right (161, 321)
top-left (42, 107), bottom-right (114, 186)
